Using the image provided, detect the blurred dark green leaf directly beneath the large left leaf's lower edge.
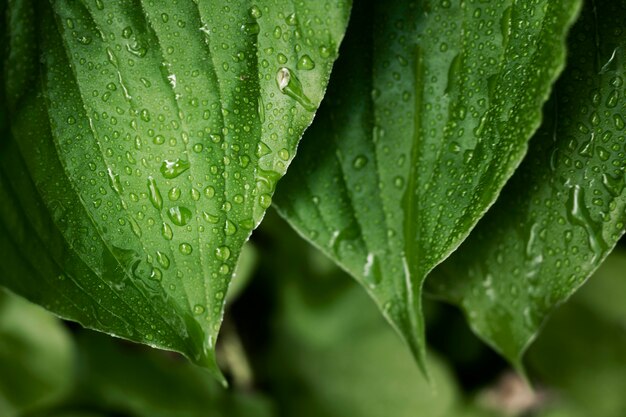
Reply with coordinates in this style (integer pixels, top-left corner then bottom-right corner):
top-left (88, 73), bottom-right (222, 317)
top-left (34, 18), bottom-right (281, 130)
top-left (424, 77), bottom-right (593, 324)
top-left (62, 332), bottom-right (273, 417)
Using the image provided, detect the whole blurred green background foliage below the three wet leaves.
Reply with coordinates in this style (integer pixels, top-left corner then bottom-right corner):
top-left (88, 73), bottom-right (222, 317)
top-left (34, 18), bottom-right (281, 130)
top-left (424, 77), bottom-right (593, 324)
top-left (0, 213), bottom-right (626, 417)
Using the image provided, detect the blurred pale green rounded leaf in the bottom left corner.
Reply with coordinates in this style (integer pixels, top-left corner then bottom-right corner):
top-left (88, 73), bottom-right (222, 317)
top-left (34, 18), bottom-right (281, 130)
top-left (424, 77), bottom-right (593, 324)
top-left (0, 290), bottom-right (74, 417)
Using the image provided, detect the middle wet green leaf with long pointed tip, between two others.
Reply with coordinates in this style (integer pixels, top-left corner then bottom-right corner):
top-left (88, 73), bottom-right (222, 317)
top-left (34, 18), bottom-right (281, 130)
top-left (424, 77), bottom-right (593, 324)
top-left (277, 0), bottom-right (579, 364)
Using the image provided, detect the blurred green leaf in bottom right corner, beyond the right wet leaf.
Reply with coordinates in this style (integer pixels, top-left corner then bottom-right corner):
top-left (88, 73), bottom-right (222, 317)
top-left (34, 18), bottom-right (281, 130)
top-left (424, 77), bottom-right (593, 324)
top-left (528, 249), bottom-right (626, 417)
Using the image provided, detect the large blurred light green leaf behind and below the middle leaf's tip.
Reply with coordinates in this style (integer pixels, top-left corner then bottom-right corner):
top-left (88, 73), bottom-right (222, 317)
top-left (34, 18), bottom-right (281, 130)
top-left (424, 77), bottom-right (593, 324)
top-left (251, 215), bottom-right (461, 417)
